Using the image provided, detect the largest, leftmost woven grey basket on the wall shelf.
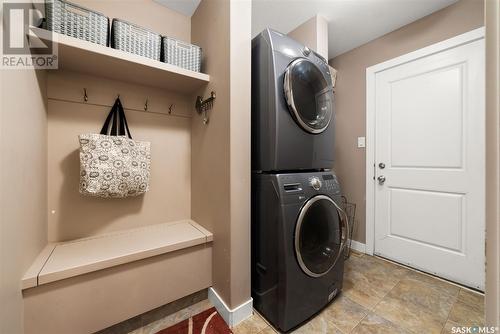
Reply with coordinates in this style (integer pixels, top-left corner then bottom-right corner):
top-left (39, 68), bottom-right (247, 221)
top-left (45, 0), bottom-right (109, 46)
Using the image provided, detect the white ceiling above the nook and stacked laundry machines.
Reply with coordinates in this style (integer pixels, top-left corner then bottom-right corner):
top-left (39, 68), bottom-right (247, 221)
top-left (155, 0), bottom-right (457, 59)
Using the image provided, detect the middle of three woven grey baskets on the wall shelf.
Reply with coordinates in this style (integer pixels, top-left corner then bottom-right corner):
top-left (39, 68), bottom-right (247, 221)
top-left (111, 19), bottom-right (161, 61)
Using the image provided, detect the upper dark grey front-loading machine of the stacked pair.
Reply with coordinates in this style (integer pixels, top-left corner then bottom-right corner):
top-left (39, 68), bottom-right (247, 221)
top-left (252, 29), bottom-right (334, 171)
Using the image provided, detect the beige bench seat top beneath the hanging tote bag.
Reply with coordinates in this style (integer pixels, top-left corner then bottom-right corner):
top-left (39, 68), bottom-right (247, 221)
top-left (22, 220), bottom-right (213, 289)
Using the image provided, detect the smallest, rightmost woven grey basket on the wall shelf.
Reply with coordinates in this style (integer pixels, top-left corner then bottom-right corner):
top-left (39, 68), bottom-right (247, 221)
top-left (163, 36), bottom-right (201, 72)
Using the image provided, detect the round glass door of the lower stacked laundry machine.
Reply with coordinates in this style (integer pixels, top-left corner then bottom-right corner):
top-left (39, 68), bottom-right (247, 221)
top-left (295, 195), bottom-right (348, 277)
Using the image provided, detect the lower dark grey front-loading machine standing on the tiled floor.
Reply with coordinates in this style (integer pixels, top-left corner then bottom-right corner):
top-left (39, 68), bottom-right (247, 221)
top-left (252, 172), bottom-right (349, 332)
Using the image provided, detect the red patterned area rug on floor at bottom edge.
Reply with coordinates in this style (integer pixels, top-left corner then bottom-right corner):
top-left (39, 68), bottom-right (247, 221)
top-left (156, 307), bottom-right (233, 334)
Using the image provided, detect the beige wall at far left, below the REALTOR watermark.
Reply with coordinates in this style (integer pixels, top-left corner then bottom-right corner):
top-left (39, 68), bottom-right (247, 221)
top-left (0, 37), bottom-right (47, 334)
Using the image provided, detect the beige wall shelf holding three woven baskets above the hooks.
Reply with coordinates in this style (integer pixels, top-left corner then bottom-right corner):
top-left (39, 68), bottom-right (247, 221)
top-left (28, 27), bottom-right (210, 94)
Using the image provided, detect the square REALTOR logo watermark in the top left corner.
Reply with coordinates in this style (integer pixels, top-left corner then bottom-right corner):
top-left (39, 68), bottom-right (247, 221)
top-left (0, 0), bottom-right (58, 69)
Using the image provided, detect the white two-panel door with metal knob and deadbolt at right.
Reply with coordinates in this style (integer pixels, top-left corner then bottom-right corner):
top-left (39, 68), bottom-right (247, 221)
top-left (374, 32), bottom-right (485, 290)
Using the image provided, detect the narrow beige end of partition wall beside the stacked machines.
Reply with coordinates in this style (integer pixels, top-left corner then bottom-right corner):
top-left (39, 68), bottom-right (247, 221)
top-left (230, 1), bottom-right (252, 307)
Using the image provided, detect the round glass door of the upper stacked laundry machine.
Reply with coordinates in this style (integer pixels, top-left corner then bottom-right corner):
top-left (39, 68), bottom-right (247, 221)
top-left (284, 58), bottom-right (333, 134)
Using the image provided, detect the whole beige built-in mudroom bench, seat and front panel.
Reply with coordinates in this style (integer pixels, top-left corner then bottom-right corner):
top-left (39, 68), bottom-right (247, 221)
top-left (21, 220), bottom-right (213, 334)
